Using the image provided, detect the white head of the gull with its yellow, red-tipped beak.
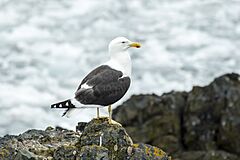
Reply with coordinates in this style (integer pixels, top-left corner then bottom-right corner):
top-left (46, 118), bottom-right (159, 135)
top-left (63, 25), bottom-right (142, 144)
top-left (108, 37), bottom-right (141, 53)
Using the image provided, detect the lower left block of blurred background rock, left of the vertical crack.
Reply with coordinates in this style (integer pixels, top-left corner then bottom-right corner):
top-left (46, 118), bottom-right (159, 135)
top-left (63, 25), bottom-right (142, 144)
top-left (113, 92), bottom-right (187, 153)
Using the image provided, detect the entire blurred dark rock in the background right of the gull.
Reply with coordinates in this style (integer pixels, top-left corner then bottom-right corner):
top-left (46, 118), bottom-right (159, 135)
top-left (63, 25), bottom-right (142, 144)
top-left (113, 73), bottom-right (240, 160)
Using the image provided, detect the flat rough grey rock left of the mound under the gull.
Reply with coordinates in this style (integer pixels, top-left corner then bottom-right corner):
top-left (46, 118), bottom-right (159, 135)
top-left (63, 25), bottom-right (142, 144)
top-left (0, 128), bottom-right (80, 160)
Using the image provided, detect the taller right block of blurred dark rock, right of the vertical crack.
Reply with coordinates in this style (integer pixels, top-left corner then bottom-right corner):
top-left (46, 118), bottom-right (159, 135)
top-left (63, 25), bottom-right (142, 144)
top-left (184, 74), bottom-right (240, 154)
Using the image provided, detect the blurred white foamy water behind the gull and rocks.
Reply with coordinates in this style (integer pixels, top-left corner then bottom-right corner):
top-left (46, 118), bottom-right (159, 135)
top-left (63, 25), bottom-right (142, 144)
top-left (0, 0), bottom-right (240, 135)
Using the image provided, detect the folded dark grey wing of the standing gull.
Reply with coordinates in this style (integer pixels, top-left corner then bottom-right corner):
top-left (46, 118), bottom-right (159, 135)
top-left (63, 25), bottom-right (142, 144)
top-left (75, 65), bottom-right (130, 106)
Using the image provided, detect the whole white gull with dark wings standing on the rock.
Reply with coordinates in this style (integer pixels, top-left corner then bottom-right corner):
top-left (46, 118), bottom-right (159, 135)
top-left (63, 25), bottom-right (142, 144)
top-left (51, 37), bottom-right (141, 123)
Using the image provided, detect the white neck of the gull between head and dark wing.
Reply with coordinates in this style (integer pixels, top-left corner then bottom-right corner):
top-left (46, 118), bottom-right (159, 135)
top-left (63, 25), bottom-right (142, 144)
top-left (106, 50), bottom-right (132, 77)
